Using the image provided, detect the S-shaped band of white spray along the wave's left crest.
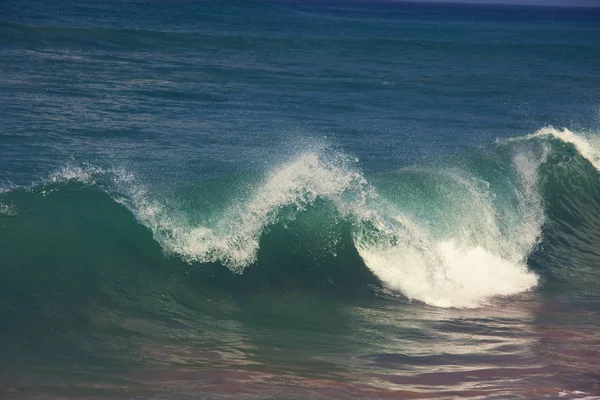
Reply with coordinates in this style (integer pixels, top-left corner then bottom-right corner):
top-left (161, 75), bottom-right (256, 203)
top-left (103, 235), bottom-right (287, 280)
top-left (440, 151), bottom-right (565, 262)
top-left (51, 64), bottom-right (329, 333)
top-left (121, 152), bottom-right (376, 273)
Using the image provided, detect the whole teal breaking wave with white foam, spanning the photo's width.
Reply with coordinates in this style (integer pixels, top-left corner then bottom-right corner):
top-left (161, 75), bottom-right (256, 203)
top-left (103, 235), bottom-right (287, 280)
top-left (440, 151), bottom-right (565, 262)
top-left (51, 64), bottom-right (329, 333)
top-left (0, 128), bottom-right (600, 308)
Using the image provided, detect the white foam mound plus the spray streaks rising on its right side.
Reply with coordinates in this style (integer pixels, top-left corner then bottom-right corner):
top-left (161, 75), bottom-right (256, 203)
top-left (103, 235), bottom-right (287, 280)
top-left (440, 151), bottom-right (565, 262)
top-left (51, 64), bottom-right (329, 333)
top-left (355, 148), bottom-right (545, 308)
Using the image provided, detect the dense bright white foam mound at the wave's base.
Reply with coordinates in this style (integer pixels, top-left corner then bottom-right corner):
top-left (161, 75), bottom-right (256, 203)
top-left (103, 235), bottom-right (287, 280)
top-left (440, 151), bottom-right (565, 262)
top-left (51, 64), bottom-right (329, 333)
top-left (358, 236), bottom-right (537, 308)
